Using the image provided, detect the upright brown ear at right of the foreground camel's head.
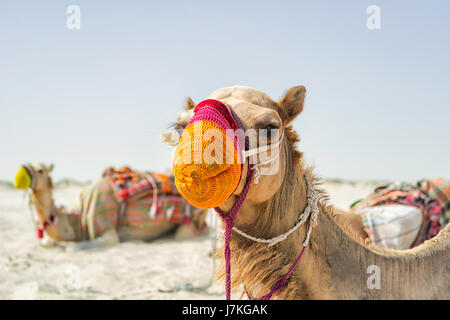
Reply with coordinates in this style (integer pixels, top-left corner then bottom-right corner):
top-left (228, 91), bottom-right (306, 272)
top-left (278, 86), bottom-right (306, 126)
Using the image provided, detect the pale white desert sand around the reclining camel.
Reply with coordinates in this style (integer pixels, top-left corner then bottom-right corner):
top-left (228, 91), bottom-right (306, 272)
top-left (0, 183), bottom-right (374, 299)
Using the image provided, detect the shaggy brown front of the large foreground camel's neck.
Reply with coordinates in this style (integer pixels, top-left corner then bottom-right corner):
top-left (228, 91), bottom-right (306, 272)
top-left (225, 136), bottom-right (312, 296)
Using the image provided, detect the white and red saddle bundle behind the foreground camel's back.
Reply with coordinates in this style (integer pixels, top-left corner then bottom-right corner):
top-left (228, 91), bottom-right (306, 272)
top-left (352, 184), bottom-right (444, 249)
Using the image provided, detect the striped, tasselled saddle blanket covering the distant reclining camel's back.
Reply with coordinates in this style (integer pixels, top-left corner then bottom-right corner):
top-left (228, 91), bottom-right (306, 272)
top-left (70, 168), bottom-right (208, 240)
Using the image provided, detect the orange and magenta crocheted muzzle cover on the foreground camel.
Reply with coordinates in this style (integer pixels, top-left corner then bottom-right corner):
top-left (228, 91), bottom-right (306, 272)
top-left (173, 99), bottom-right (243, 208)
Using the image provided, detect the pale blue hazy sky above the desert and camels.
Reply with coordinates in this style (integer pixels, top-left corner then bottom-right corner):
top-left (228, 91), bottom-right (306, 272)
top-left (0, 1), bottom-right (450, 180)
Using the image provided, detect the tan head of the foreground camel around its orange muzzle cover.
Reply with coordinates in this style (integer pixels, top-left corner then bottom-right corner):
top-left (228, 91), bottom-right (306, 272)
top-left (175, 86), bottom-right (306, 222)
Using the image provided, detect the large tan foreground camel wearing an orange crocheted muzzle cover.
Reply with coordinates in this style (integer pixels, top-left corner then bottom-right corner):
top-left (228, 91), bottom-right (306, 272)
top-left (172, 86), bottom-right (450, 299)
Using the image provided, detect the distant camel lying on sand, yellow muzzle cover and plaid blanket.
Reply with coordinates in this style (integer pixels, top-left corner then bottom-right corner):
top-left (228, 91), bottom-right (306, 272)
top-left (16, 163), bottom-right (207, 248)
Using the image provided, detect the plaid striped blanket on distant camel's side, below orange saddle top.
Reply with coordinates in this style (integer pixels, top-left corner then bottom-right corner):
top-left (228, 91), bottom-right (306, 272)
top-left (69, 172), bottom-right (207, 241)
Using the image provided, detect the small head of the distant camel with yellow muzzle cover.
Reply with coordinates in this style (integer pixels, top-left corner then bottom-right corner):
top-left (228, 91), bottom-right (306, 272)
top-left (14, 163), bottom-right (53, 192)
